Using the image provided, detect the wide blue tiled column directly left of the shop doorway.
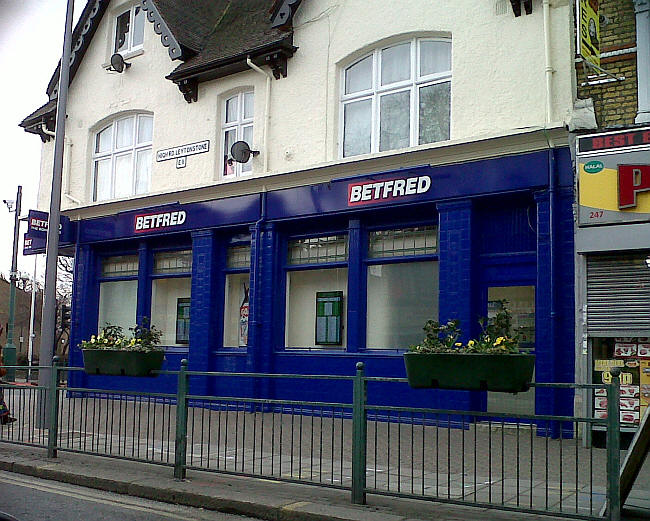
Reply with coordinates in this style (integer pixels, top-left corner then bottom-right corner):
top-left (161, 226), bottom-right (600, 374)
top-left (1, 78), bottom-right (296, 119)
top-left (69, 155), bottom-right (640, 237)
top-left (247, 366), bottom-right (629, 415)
top-left (436, 201), bottom-right (474, 409)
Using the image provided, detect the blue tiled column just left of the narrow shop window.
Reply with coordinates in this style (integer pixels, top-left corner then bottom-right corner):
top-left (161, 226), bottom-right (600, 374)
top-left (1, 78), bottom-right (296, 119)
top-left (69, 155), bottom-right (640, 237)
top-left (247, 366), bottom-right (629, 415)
top-left (188, 230), bottom-right (223, 394)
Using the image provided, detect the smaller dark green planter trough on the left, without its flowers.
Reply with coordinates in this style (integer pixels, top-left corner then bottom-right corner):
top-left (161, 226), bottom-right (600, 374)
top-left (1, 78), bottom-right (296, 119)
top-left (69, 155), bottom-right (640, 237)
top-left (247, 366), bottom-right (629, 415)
top-left (82, 349), bottom-right (165, 376)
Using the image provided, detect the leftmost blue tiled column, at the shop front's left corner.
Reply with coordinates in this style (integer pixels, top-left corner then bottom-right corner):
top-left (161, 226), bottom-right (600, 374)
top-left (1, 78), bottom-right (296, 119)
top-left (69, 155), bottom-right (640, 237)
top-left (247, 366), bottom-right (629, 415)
top-left (68, 244), bottom-right (99, 387)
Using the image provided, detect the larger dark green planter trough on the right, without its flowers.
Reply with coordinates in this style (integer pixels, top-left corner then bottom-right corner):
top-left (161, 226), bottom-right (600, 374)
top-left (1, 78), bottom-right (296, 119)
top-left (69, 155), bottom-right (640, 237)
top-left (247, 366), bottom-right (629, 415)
top-left (404, 353), bottom-right (535, 393)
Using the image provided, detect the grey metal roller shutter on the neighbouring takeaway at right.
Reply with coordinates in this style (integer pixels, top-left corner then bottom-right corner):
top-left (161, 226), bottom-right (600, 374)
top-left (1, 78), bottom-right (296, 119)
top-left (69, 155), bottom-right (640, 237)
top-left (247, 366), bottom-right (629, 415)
top-left (587, 252), bottom-right (650, 337)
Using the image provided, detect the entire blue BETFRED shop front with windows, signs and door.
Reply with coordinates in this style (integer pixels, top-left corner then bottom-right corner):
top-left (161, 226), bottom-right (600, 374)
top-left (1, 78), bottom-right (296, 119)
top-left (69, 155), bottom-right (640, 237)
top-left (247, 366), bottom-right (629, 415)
top-left (39, 144), bottom-right (574, 413)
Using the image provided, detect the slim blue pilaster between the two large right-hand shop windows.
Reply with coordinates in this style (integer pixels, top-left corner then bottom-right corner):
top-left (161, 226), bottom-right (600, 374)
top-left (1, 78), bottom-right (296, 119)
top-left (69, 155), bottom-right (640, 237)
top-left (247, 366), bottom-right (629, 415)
top-left (346, 219), bottom-right (366, 353)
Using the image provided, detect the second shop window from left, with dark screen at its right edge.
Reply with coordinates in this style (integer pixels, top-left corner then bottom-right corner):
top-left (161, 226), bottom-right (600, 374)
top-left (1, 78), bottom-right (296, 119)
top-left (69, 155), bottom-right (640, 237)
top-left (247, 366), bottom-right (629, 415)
top-left (151, 250), bottom-right (192, 346)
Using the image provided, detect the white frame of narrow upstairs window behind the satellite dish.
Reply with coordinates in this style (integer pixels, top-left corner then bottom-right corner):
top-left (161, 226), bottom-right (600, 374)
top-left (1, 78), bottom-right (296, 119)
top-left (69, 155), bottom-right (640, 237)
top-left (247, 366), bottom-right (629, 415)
top-left (219, 89), bottom-right (255, 180)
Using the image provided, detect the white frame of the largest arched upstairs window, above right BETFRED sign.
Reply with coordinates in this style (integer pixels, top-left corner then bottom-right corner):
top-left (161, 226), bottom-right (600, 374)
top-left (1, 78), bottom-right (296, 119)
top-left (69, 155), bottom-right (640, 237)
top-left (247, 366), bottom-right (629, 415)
top-left (338, 37), bottom-right (453, 159)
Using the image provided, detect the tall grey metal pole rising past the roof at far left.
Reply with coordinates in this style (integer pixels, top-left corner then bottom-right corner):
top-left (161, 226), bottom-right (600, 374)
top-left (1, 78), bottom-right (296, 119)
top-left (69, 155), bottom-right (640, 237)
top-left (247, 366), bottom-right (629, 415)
top-left (38, 0), bottom-right (74, 392)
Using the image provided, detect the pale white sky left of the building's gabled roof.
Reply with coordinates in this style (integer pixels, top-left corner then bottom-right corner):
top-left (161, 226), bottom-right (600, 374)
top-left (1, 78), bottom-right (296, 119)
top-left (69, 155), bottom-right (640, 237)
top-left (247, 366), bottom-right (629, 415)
top-left (0, 0), bottom-right (86, 279)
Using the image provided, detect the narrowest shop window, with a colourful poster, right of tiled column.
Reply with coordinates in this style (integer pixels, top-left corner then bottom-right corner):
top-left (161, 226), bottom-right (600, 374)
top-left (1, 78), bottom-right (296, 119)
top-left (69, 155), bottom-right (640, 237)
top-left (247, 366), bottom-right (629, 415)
top-left (223, 244), bottom-right (251, 347)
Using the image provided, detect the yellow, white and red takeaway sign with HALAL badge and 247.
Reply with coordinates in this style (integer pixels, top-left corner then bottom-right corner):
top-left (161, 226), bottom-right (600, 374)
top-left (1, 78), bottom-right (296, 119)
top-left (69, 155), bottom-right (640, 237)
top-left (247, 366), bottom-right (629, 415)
top-left (577, 128), bottom-right (650, 226)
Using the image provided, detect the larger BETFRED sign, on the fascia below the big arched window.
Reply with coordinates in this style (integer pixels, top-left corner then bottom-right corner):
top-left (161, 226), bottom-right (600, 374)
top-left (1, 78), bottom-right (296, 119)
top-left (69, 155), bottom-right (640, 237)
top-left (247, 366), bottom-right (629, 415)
top-left (348, 175), bottom-right (431, 206)
